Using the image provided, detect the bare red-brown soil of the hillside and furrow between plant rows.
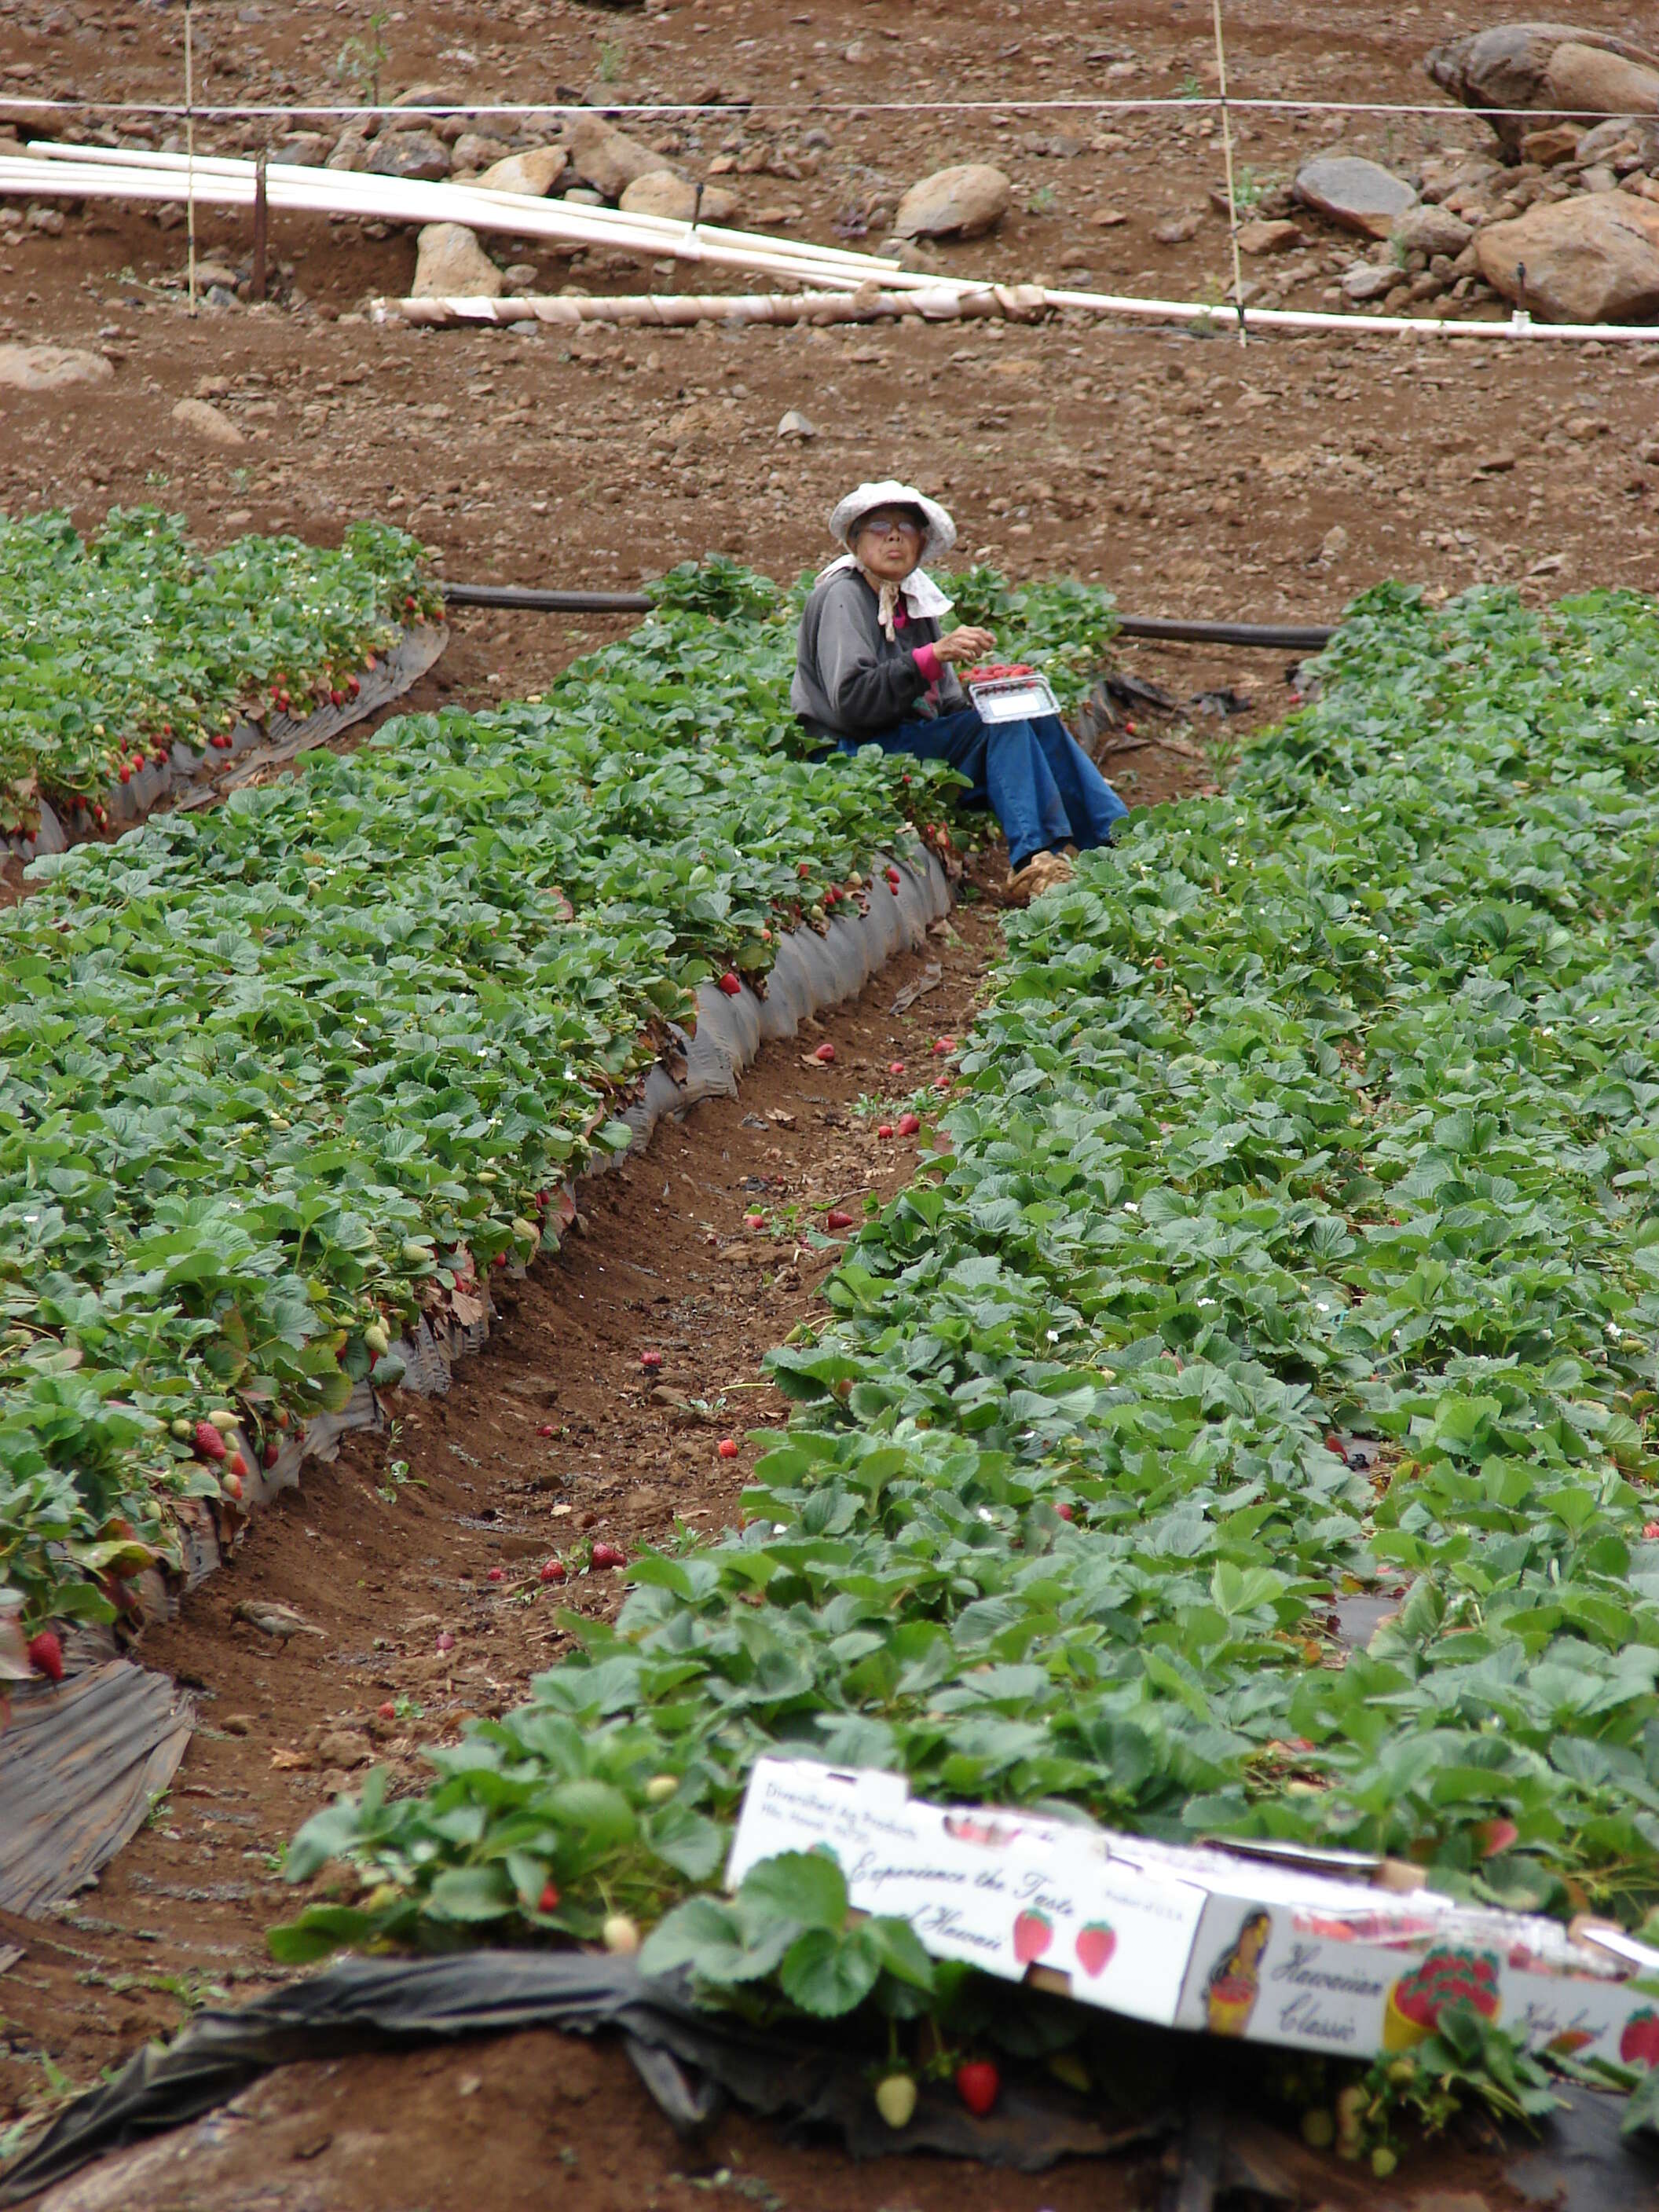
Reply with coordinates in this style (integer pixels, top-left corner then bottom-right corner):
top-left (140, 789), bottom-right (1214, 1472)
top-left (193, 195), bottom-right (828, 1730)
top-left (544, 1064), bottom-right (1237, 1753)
top-left (0, 0), bottom-right (1659, 2212)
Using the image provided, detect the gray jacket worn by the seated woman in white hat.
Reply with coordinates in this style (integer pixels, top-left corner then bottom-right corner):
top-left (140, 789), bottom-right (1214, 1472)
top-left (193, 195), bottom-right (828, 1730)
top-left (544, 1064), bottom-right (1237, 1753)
top-left (789, 569), bottom-right (967, 745)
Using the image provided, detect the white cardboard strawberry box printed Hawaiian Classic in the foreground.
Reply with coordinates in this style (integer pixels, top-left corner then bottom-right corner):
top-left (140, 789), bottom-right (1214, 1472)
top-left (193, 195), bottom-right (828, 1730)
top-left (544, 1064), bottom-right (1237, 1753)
top-left (727, 1759), bottom-right (1659, 2066)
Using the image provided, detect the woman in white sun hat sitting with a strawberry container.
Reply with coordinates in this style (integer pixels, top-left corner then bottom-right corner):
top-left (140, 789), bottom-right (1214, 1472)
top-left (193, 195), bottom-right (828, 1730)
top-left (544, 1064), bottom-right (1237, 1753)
top-left (789, 482), bottom-right (1128, 905)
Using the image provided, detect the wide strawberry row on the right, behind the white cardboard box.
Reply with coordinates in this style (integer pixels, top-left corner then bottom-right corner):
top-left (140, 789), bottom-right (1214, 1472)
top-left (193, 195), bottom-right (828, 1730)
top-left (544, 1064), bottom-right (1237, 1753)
top-left (272, 591), bottom-right (1659, 2013)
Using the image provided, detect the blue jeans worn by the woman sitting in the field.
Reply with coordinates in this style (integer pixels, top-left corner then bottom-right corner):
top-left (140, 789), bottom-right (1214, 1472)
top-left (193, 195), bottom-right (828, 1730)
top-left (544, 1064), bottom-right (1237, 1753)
top-left (840, 705), bottom-right (1128, 867)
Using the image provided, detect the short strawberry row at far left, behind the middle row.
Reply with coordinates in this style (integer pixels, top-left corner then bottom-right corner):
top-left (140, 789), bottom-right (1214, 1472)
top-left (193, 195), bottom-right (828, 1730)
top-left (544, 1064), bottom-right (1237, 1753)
top-left (0, 507), bottom-right (442, 836)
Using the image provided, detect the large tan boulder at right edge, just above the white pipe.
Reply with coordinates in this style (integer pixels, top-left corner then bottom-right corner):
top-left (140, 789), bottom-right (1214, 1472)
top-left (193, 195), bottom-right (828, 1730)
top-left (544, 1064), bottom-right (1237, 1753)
top-left (1475, 192), bottom-right (1659, 323)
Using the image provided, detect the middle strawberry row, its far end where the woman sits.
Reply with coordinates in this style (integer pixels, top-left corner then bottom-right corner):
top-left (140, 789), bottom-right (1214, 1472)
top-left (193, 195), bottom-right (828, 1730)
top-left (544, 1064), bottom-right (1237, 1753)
top-left (0, 580), bottom-right (986, 1626)
